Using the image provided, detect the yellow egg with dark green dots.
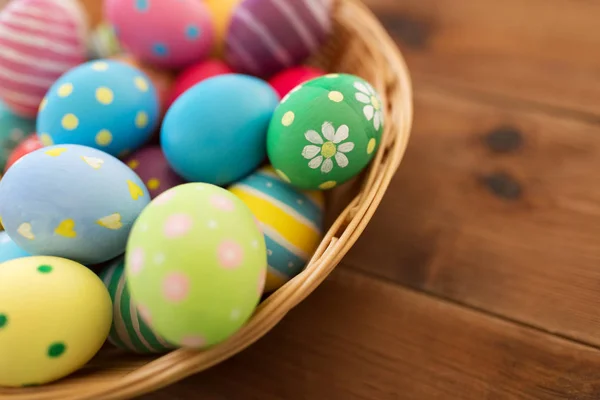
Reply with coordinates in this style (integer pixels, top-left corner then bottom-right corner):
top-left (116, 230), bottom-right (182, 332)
top-left (0, 257), bottom-right (112, 387)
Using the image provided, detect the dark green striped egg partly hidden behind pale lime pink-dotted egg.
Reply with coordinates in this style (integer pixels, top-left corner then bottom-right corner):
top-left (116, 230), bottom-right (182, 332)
top-left (100, 257), bottom-right (175, 354)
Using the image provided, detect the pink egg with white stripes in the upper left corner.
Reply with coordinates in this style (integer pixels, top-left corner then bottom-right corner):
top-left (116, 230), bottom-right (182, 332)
top-left (0, 0), bottom-right (87, 117)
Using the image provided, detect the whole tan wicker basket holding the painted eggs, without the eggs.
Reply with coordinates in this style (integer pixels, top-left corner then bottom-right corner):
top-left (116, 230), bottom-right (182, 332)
top-left (0, 0), bottom-right (412, 400)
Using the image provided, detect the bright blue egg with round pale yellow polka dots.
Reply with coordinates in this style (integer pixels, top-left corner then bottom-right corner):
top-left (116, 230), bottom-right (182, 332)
top-left (37, 60), bottom-right (159, 157)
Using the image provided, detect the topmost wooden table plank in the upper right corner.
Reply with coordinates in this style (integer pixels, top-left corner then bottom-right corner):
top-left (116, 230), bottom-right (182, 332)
top-left (364, 0), bottom-right (600, 120)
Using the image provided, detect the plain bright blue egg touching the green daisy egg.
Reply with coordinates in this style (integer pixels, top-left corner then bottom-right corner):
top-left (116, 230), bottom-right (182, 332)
top-left (161, 74), bottom-right (279, 186)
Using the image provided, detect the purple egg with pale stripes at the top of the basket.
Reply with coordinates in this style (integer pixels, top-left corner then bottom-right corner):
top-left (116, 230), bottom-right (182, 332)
top-left (225, 0), bottom-right (333, 77)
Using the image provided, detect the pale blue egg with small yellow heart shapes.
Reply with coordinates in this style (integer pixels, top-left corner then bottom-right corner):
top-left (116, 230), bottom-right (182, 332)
top-left (0, 145), bottom-right (150, 264)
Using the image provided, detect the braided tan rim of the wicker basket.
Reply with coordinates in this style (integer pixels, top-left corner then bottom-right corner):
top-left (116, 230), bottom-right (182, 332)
top-left (0, 0), bottom-right (413, 400)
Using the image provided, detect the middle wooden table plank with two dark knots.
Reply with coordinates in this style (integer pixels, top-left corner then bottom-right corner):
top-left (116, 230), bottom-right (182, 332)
top-left (340, 84), bottom-right (600, 345)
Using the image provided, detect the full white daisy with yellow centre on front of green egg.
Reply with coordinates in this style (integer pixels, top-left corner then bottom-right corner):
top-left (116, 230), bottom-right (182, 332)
top-left (302, 122), bottom-right (354, 174)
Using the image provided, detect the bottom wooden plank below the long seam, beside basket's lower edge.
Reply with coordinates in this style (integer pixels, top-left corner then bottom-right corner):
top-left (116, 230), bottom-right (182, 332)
top-left (144, 267), bottom-right (600, 400)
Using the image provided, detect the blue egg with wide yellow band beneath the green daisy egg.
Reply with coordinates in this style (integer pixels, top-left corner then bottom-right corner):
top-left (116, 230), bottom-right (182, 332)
top-left (229, 166), bottom-right (324, 293)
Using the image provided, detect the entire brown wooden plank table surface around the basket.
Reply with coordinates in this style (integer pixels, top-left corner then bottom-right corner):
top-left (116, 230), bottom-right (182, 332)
top-left (84, 0), bottom-right (600, 400)
